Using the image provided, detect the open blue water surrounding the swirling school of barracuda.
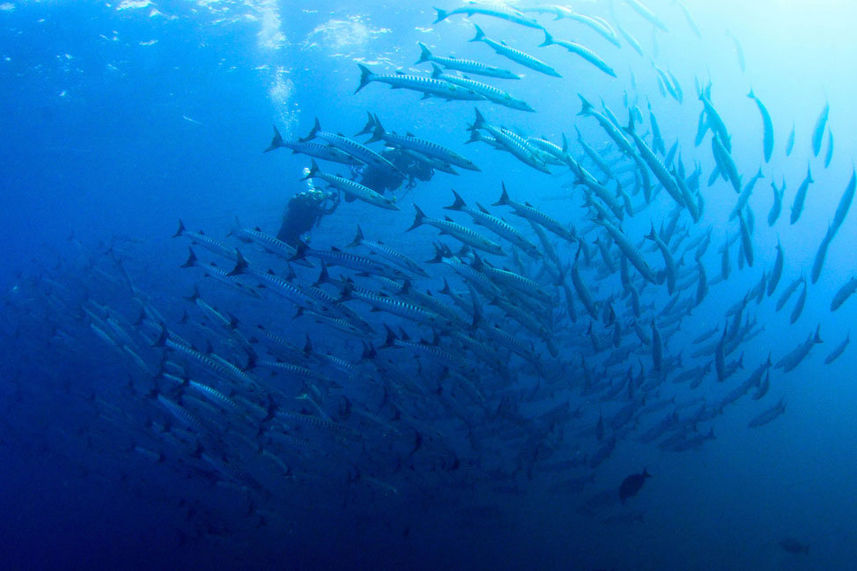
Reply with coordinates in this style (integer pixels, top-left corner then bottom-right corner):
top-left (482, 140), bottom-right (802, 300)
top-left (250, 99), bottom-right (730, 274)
top-left (0, 0), bottom-right (857, 569)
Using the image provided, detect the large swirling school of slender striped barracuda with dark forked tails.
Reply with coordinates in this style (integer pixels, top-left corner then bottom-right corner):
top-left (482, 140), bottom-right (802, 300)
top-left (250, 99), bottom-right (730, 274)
top-left (3, 0), bottom-right (857, 536)
